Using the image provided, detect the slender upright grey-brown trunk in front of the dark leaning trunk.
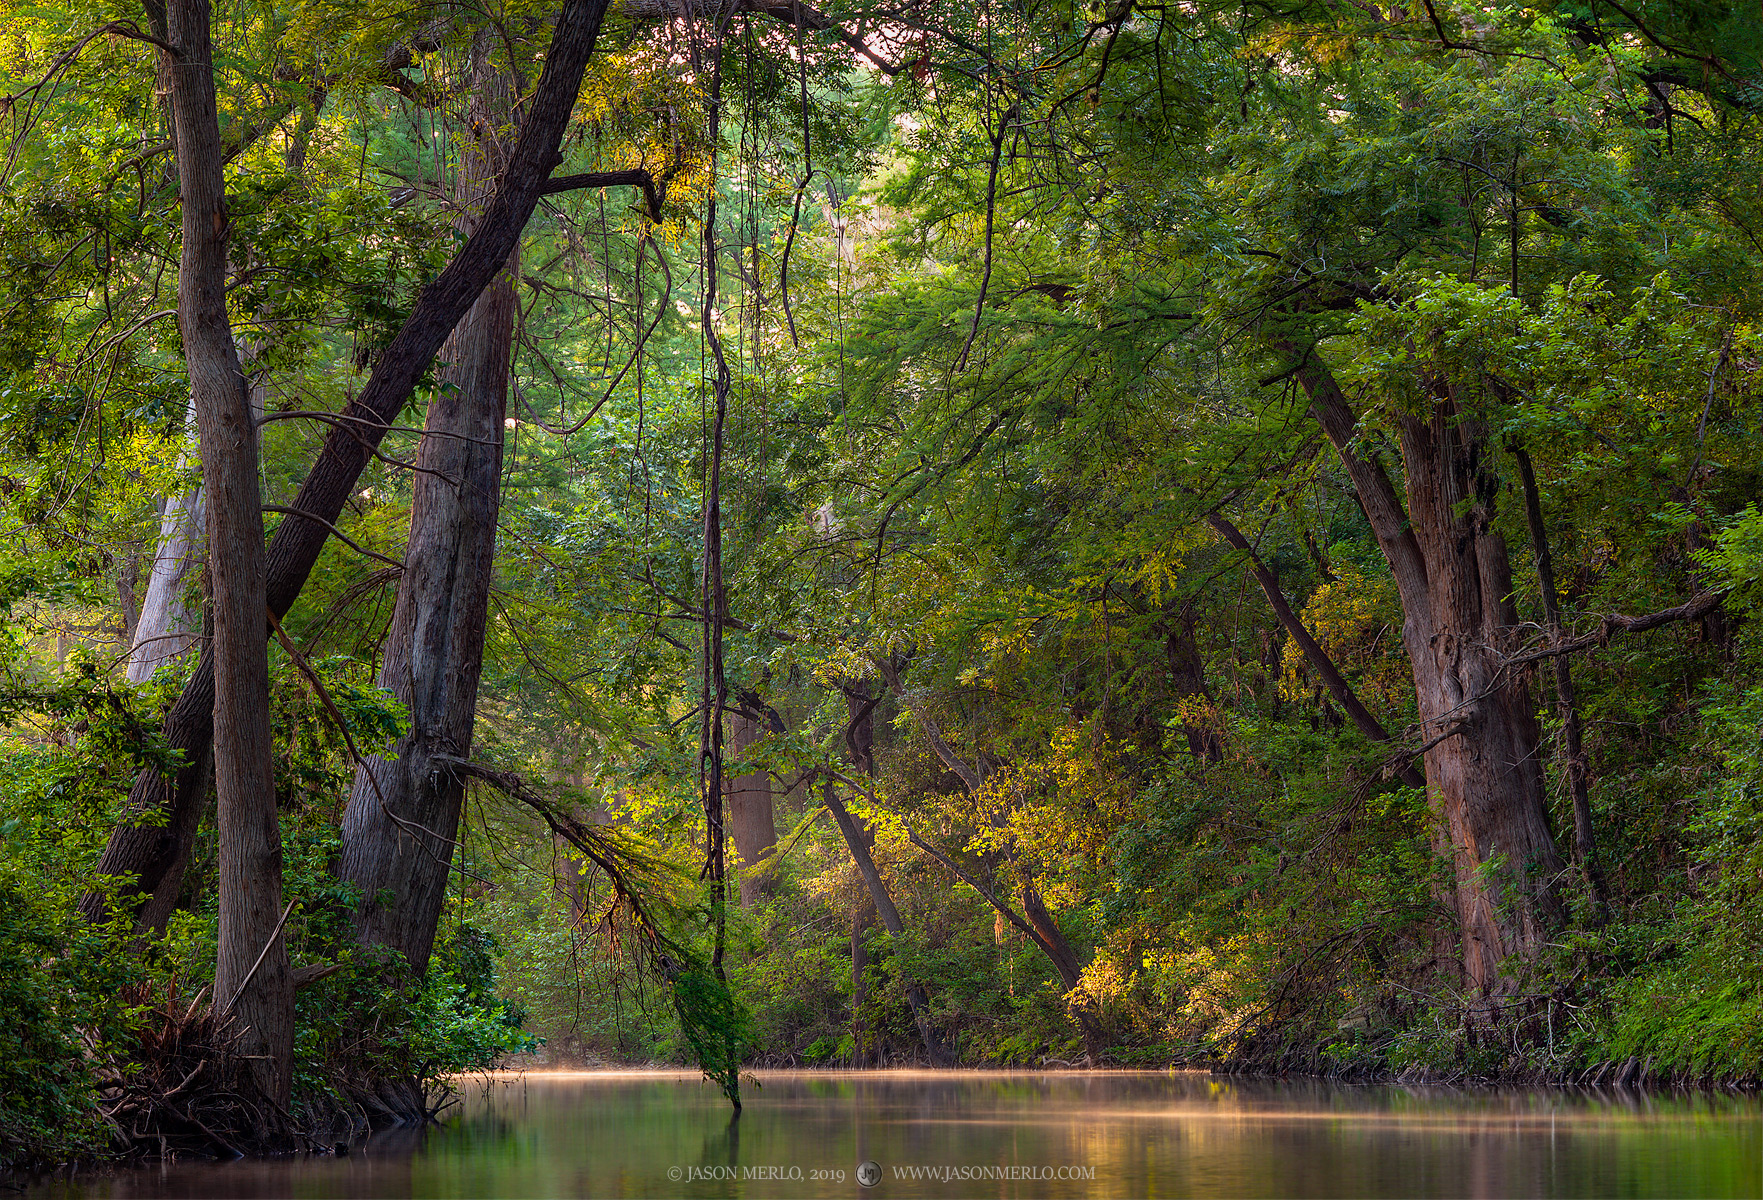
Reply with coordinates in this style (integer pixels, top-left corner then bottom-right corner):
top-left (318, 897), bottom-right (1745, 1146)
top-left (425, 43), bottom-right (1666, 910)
top-left (167, 0), bottom-right (294, 1105)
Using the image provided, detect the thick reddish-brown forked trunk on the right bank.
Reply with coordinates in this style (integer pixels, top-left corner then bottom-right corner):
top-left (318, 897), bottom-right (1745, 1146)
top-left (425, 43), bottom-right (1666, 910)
top-left (1280, 345), bottom-right (1560, 999)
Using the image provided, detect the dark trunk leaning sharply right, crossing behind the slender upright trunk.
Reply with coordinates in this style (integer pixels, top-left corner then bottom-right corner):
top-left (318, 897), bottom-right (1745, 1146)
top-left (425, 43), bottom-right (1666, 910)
top-left (81, 0), bottom-right (620, 918)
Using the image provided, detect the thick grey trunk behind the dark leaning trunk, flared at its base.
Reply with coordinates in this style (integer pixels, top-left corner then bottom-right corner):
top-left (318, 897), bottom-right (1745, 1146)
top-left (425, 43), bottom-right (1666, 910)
top-left (337, 35), bottom-right (520, 974)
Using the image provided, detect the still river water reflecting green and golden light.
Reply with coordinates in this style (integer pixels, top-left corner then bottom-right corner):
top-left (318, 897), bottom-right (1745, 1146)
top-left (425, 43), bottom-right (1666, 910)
top-left (30, 1071), bottom-right (1763, 1200)
